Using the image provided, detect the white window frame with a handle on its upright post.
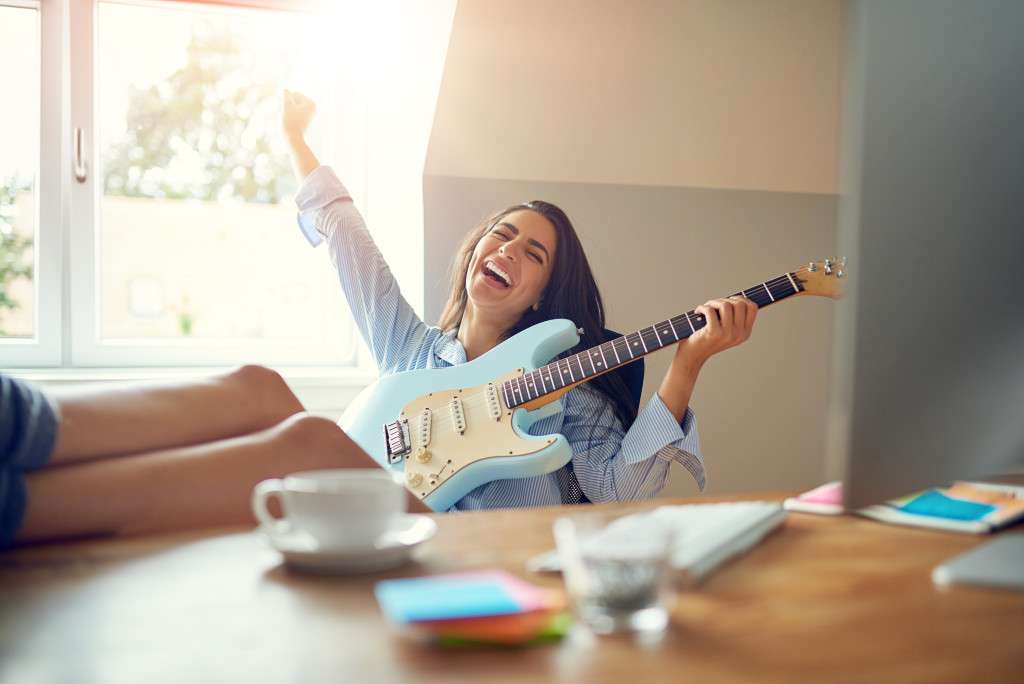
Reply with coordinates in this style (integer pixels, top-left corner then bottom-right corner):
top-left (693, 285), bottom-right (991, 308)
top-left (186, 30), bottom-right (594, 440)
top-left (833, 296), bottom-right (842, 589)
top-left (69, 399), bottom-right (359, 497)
top-left (0, 0), bottom-right (366, 369)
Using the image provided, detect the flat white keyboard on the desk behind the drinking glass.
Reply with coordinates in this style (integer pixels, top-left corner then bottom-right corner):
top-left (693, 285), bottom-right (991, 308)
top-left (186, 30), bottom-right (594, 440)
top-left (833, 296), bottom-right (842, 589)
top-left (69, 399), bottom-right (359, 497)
top-left (526, 501), bottom-right (786, 586)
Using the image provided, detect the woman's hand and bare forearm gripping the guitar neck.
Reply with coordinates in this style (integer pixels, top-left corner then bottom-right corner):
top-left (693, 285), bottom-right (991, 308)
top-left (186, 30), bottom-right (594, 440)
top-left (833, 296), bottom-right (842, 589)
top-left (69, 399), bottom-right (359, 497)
top-left (657, 296), bottom-right (758, 423)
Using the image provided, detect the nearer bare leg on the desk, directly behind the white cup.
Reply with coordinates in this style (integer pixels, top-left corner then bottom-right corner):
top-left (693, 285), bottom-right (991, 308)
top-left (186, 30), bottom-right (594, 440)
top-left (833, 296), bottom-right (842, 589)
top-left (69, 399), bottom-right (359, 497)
top-left (16, 414), bottom-right (429, 544)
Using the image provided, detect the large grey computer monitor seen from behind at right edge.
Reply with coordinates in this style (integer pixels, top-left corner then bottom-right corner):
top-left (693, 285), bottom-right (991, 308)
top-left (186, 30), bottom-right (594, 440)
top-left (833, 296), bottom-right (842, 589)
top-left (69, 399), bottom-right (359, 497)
top-left (828, 0), bottom-right (1024, 509)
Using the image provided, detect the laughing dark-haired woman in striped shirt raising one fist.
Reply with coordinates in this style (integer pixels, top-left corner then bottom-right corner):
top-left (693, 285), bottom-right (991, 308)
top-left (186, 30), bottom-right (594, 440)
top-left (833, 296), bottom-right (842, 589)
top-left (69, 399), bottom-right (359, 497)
top-left (283, 90), bottom-right (757, 510)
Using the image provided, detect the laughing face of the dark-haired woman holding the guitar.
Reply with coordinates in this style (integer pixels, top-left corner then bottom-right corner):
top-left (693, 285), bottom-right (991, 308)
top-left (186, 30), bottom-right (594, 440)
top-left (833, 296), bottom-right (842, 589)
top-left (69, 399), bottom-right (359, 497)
top-left (466, 209), bottom-right (557, 327)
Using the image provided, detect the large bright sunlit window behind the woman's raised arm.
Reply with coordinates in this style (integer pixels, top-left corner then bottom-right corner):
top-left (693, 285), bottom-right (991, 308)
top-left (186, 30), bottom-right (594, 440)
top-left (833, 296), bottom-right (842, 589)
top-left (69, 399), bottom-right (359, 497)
top-left (0, 0), bottom-right (454, 368)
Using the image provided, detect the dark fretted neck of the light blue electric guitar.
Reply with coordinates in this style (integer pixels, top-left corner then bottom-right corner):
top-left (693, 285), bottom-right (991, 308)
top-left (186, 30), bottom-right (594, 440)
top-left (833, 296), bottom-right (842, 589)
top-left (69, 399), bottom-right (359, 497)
top-left (502, 272), bottom-right (804, 409)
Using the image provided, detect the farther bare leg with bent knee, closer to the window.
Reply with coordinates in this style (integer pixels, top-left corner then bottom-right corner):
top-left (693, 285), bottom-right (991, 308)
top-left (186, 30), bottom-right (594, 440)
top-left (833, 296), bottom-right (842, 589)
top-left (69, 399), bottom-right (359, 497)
top-left (50, 366), bottom-right (302, 465)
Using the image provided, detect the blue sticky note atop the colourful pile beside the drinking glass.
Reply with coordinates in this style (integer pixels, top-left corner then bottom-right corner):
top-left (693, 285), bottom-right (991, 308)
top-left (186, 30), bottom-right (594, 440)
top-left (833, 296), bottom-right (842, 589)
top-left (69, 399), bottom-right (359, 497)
top-left (374, 575), bottom-right (523, 623)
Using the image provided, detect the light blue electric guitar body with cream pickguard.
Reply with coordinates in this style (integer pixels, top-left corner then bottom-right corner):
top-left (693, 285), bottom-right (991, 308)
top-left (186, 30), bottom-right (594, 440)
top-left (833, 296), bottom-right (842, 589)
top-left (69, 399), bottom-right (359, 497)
top-left (339, 318), bottom-right (580, 511)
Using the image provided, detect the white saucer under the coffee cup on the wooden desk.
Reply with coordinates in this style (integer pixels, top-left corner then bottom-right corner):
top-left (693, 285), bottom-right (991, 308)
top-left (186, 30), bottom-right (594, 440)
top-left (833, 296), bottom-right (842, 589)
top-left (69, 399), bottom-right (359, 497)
top-left (259, 514), bottom-right (437, 574)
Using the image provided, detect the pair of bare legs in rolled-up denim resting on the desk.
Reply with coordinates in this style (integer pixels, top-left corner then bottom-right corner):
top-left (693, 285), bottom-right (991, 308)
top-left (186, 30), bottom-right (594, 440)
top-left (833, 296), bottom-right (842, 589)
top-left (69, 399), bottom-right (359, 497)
top-left (0, 366), bottom-right (391, 550)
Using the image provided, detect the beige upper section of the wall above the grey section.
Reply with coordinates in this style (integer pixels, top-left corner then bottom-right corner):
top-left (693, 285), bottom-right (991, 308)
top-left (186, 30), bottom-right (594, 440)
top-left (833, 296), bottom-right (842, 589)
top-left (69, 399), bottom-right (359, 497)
top-left (425, 0), bottom-right (842, 194)
